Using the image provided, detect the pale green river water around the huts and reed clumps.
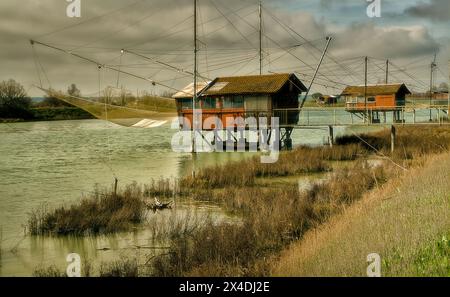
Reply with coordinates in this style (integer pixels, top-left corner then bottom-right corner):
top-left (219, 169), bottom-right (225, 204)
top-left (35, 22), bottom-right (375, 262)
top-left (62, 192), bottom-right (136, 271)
top-left (0, 120), bottom-right (382, 276)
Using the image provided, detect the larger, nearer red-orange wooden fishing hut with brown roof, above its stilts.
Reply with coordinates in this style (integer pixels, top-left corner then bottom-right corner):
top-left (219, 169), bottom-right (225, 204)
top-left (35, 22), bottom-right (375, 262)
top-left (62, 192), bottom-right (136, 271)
top-left (173, 73), bottom-right (307, 128)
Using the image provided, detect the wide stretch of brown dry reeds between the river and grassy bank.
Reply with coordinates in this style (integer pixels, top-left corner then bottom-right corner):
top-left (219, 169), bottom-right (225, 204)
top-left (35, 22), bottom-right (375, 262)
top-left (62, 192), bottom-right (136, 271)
top-left (154, 127), bottom-right (450, 276)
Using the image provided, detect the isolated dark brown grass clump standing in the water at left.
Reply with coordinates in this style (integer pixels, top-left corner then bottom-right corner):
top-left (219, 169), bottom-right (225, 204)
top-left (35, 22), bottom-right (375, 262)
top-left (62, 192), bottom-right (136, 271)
top-left (27, 184), bottom-right (146, 235)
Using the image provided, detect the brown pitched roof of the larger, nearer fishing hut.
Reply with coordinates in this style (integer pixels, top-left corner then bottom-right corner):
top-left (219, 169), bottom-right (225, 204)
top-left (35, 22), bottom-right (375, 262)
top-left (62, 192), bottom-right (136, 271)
top-left (203, 73), bottom-right (307, 95)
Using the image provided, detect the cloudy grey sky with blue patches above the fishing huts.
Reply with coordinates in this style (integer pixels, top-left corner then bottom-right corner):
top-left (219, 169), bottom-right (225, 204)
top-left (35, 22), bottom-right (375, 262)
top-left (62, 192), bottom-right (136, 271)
top-left (0, 0), bottom-right (450, 96)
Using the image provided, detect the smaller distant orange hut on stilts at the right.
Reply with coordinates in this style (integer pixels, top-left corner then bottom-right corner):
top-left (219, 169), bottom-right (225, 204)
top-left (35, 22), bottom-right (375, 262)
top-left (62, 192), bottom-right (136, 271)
top-left (341, 84), bottom-right (411, 121)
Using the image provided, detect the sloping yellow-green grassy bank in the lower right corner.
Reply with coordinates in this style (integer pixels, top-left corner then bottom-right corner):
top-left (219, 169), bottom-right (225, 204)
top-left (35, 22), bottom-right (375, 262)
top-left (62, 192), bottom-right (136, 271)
top-left (272, 153), bottom-right (450, 276)
